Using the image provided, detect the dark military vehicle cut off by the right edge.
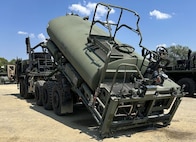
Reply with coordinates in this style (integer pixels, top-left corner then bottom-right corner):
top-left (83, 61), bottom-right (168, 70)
top-left (165, 50), bottom-right (196, 96)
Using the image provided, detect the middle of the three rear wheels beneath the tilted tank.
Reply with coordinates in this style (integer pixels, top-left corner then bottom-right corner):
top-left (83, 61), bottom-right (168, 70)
top-left (42, 81), bottom-right (54, 110)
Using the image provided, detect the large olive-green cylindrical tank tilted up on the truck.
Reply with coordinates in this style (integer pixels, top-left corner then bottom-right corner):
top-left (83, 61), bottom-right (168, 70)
top-left (47, 15), bottom-right (148, 90)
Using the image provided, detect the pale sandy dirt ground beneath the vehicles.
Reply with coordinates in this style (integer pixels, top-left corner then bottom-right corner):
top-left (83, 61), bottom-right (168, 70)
top-left (0, 84), bottom-right (196, 142)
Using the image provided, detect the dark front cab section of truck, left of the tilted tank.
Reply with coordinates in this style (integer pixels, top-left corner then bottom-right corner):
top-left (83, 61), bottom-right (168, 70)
top-left (16, 37), bottom-right (53, 99)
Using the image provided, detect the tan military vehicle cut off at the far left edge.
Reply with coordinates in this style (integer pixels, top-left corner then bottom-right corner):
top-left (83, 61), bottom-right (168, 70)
top-left (0, 65), bottom-right (15, 84)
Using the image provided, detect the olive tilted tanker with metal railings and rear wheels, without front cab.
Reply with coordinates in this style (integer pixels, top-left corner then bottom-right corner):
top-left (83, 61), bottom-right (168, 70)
top-left (14, 3), bottom-right (183, 137)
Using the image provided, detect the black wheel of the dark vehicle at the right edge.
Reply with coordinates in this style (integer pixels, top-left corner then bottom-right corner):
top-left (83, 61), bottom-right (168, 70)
top-left (178, 78), bottom-right (195, 96)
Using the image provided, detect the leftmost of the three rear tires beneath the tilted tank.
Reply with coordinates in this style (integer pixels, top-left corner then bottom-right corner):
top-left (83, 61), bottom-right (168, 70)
top-left (35, 80), bottom-right (45, 106)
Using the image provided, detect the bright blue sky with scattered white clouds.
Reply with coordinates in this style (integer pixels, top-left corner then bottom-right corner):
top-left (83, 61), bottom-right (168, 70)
top-left (0, 0), bottom-right (196, 61)
